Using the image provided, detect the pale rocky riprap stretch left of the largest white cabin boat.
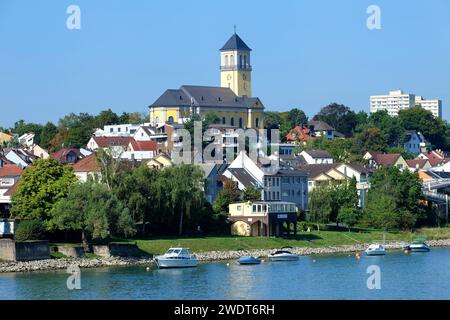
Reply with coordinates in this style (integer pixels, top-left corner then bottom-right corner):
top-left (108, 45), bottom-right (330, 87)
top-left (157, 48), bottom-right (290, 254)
top-left (0, 257), bottom-right (151, 273)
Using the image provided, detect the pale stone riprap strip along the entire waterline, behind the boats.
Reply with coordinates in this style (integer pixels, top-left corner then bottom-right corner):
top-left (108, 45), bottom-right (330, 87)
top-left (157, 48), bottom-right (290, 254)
top-left (0, 239), bottom-right (450, 273)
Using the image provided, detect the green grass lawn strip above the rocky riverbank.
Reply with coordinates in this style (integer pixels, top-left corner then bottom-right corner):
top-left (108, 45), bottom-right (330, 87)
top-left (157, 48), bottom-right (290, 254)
top-left (50, 228), bottom-right (450, 254)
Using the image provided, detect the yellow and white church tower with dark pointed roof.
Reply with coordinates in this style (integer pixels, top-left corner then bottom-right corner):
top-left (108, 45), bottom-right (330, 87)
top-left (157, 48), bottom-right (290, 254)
top-left (220, 31), bottom-right (252, 97)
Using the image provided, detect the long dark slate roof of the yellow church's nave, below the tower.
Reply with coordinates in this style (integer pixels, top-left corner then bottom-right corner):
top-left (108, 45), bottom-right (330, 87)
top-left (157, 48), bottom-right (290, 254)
top-left (150, 86), bottom-right (263, 108)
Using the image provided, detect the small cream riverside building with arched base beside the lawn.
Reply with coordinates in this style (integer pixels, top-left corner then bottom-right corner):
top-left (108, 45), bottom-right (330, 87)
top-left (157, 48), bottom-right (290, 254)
top-left (228, 201), bottom-right (298, 237)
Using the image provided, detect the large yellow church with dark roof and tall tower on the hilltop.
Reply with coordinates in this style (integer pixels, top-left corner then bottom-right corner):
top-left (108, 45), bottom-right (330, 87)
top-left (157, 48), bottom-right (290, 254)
top-left (149, 33), bottom-right (264, 129)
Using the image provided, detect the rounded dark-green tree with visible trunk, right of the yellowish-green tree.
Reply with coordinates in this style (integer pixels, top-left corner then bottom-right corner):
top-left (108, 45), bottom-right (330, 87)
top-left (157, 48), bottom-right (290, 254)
top-left (52, 180), bottom-right (136, 252)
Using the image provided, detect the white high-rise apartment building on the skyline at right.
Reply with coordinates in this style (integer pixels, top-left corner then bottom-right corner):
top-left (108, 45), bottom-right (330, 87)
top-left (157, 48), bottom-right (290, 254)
top-left (370, 90), bottom-right (442, 118)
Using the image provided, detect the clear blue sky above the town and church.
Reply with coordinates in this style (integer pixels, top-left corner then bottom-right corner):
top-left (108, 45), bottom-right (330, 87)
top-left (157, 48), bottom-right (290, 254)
top-left (0, 0), bottom-right (450, 126)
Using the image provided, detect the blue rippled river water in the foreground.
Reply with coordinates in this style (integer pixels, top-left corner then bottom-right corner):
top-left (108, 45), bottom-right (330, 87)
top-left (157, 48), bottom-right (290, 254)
top-left (0, 248), bottom-right (450, 300)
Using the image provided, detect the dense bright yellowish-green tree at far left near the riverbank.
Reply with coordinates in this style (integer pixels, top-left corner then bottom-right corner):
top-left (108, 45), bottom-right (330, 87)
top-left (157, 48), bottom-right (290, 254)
top-left (11, 159), bottom-right (77, 229)
